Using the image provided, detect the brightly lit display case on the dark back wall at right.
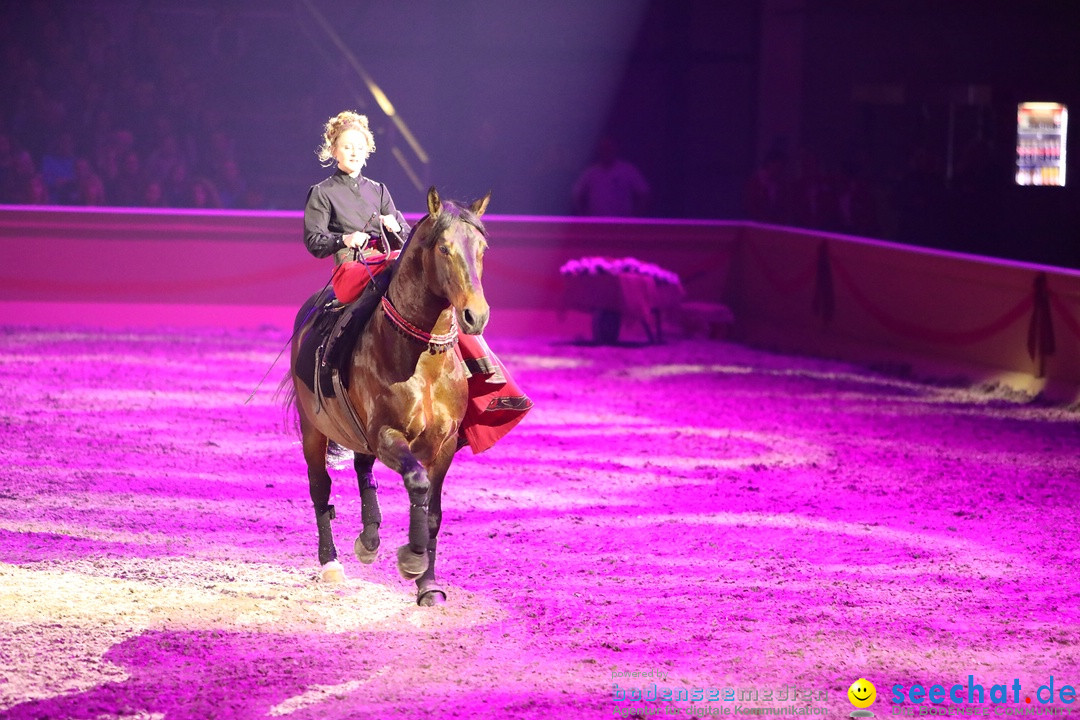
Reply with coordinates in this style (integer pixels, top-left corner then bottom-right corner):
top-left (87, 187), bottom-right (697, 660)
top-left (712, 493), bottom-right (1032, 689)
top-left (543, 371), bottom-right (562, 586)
top-left (1016, 103), bottom-right (1069, 187)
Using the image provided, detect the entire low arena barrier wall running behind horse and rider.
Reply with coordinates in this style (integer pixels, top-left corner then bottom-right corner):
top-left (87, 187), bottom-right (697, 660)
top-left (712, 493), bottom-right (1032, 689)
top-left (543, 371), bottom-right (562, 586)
top-left (0, 206), bottom-right (1080, 395)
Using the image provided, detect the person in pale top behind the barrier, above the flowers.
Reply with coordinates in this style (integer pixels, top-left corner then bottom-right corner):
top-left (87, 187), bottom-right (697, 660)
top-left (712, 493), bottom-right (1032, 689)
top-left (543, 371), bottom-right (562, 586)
top-left (573, 137), bottom-right (650, 217)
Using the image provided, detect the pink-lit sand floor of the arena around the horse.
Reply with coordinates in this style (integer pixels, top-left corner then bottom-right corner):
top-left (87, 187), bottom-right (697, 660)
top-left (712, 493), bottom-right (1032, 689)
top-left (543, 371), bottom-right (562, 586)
top-left (0, 328), bottom-right (1080, 720)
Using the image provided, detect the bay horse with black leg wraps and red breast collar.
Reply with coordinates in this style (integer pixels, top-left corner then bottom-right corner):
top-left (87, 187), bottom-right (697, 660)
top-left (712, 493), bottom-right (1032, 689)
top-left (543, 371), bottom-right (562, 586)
top-left (286, 187), bottom-right (490, 606)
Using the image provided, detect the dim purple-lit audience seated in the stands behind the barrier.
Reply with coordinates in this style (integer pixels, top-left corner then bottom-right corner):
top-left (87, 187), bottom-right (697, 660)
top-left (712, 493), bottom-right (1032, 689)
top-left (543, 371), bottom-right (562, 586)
top-left (0, 0), bottom-right (265, 208)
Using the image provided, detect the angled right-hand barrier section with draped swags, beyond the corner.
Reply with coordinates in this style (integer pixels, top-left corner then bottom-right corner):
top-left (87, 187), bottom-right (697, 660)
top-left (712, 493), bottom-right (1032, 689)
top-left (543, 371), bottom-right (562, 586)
top-left (726, 223), bottom-right (1080, 396)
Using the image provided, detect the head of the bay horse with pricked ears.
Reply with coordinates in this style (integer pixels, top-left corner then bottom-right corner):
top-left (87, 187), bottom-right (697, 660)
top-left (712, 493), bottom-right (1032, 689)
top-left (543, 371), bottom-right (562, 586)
top-left (416, 188), bottom-right (491, 335)
